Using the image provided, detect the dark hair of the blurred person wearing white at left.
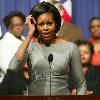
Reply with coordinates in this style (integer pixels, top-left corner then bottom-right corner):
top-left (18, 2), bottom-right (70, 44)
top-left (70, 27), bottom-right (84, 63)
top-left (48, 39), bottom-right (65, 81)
top-left (3, 11), bottom-right (26, 28)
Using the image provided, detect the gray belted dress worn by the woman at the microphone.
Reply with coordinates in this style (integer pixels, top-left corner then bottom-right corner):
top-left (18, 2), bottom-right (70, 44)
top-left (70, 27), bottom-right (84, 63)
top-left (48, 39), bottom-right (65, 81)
top-left (9, 42), bottom-right (86, 95)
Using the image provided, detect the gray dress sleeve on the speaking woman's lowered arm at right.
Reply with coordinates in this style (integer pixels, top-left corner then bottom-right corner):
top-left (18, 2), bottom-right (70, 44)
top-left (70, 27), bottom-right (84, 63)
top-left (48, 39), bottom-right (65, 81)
top-left (70, 44), bottom-right (87, 95)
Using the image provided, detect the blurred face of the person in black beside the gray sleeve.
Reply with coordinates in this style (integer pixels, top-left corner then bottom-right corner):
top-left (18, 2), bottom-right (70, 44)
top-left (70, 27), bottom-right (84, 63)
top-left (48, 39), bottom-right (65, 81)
top-left (79, 45), bottom-right (91, 64)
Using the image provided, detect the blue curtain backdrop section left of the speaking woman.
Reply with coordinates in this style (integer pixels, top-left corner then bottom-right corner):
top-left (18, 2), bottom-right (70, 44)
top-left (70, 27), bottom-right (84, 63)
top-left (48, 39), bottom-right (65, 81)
top-left (0, 0), bottom-right (39, 35)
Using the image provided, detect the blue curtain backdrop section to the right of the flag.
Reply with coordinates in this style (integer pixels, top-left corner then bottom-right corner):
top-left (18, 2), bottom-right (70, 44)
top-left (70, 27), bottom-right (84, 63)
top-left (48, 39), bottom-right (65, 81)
top-left (72, 0), bottom-right (100, 39)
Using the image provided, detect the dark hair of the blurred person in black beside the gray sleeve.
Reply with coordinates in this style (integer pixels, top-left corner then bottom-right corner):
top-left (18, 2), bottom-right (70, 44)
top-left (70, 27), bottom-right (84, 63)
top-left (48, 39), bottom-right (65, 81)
top-left (76, 40), bottom-right (94, 56)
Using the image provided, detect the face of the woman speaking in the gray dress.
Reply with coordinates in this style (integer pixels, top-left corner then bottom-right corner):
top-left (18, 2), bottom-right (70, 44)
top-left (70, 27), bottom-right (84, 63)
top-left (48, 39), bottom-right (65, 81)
top-left (37, 13), bottom-right (56, 42)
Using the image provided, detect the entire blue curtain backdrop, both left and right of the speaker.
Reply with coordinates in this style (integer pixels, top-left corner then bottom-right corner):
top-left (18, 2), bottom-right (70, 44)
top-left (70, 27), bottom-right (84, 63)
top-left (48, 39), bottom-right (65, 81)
top-left (0, 0), bottom-right (100, 39)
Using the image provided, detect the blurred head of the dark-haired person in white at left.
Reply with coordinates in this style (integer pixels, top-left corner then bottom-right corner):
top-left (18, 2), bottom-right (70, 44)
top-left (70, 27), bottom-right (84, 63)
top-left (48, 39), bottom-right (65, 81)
top-left (3, 11), bottom-right (26, 38)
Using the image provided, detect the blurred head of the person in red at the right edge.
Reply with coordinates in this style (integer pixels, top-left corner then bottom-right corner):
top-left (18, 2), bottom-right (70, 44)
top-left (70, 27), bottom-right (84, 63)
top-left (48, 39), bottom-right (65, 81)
top-left (89, 17), bottom-right (100, 39)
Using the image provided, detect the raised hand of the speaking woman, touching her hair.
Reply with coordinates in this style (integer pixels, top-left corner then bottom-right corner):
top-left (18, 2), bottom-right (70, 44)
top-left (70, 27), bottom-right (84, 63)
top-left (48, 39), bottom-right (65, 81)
top-left (25, 15), bottom-right (36, 35)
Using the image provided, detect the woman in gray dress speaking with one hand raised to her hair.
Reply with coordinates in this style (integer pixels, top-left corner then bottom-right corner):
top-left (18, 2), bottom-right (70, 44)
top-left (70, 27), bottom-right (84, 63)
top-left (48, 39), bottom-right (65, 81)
top-left (9, 2), bottom-right (86, 95)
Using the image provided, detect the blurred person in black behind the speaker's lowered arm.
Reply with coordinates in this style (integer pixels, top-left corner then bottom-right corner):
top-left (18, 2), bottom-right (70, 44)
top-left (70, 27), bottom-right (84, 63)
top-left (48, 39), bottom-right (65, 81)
top-left (72, 40), bottom-right (96, 95)
